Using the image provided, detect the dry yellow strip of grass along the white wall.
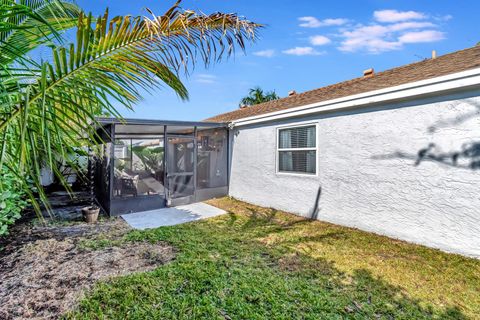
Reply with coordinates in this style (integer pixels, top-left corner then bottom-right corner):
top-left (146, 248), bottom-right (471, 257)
top-left (209, 198), bottom-right (480, 318)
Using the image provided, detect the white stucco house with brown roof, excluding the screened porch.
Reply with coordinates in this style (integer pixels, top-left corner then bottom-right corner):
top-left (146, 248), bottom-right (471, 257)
top-left (206, 46), bottom-right (480, 256)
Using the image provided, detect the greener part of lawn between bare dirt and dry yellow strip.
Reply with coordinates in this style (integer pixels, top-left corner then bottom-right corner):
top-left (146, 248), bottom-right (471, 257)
top-left (68, 208), bottom-right (467, 319)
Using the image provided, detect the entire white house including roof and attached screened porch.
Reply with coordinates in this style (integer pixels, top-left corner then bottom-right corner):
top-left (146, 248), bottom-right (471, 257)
top-left (96, 46), bottom-right (480, 257)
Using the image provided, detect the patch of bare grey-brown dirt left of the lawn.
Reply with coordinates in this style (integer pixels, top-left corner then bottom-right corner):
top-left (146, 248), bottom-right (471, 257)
top-left (0, 219), bottom-right (175, 319)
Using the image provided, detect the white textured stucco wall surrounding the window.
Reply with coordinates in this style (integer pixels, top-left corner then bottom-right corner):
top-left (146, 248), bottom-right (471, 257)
top-left (230, 90), bottom-right (480, 257)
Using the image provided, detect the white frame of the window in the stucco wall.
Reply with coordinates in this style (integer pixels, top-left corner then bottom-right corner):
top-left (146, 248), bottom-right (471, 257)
top-left (275, 121), bottom-right (319, 177)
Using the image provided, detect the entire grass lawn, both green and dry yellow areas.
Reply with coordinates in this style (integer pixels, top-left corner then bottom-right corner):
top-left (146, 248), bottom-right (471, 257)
top-left (67, 198), bottom-right (480, 320)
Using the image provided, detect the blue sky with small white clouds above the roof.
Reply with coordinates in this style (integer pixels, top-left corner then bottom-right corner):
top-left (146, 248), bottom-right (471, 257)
top-left (77, 0), bottom-right (480, 120)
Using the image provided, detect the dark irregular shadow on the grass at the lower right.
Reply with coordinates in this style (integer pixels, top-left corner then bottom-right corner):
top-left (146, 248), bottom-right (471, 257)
top-left (277, 252), bottom-right (468, 320)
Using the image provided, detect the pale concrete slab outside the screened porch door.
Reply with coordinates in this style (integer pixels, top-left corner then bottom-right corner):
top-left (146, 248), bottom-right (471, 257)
top-left (122, 202), bottom-right (226, 230)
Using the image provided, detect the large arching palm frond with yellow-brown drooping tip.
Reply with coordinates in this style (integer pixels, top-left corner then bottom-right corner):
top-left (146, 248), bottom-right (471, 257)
top-left (0, 2), bottom-right (260, 215)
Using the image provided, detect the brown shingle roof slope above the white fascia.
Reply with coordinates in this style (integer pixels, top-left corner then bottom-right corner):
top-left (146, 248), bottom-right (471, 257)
top-left (205, 46), bottom-right (480, 122)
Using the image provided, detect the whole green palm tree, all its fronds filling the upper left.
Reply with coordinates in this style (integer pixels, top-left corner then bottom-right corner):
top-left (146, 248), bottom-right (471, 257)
top-left (0, 0), bottom-right (260, 218)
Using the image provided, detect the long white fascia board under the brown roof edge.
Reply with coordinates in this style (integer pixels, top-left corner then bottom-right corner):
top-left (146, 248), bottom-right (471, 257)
top-left (231, 68), bottom-right (480, 127)
